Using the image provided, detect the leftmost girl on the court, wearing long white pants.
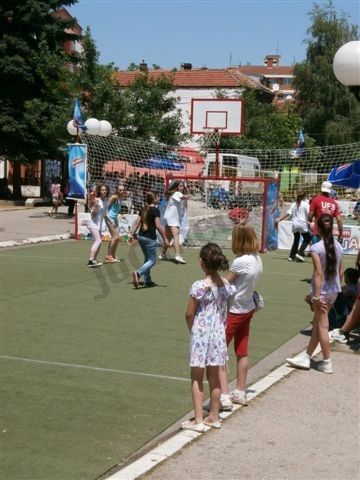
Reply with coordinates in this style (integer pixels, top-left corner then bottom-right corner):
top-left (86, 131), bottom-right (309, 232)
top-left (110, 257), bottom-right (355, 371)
top-left (88, 184), bottom-right (109, 268)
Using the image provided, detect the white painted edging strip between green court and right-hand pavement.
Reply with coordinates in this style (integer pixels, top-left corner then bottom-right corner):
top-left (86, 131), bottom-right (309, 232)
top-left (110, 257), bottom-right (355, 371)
top-left (106, 347), bottom-right (320, 480)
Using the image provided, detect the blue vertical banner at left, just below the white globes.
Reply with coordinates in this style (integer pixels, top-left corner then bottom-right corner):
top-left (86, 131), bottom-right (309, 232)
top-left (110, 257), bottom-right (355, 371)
top-left (67, 143), bottom-right (87, 200)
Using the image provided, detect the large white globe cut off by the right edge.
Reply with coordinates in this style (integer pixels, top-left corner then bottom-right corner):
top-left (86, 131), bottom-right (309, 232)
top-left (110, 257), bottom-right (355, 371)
top-left (333, 41), bottom-right (360, 86)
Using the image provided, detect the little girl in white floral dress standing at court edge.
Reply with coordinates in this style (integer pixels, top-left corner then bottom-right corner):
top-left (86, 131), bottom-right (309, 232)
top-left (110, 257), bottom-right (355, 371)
top-left (182, 243), bottom-right (234, 432)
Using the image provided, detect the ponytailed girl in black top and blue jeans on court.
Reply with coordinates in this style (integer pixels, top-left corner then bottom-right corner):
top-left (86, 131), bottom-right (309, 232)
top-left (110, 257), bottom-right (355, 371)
top-left (130, 192), bottom-right (169, 288)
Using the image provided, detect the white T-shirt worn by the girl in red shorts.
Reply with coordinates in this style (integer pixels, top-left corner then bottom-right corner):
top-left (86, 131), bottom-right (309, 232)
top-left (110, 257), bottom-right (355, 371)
top-left (229, 254), bottom-right (263, 313)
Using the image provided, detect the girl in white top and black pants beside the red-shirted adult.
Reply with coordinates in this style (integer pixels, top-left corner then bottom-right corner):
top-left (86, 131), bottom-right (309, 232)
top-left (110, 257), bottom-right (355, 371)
top-left (276, 192), bottom-right (311, 262)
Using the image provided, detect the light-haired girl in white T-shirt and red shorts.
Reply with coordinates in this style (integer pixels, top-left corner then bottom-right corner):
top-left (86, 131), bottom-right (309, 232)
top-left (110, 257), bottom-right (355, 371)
top-left (219, 223), bottom-right (263, 410)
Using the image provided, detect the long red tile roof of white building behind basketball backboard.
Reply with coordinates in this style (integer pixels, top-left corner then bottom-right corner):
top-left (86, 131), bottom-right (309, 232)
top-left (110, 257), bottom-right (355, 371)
top-left (115, 69), bottom-right (271, 92)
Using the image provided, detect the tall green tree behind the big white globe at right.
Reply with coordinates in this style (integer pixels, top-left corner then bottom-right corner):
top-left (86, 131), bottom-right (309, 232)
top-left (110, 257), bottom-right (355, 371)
top-left (294, 1), bottom-right (360, 145)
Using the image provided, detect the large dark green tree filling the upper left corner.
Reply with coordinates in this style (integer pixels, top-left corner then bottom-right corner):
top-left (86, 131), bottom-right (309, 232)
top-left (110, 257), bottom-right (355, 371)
top-left (0, 0), bottom-right (77, 197)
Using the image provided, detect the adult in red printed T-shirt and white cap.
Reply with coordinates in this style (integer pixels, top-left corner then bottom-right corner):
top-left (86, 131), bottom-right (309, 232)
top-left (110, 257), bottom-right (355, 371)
top-left (308, 181), bottom-right (343, 243)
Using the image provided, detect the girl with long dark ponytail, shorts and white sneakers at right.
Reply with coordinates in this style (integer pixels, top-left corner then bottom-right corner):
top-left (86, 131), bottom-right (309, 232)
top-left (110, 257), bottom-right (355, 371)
top-left (286, 214), bottom-right (343, 373)
